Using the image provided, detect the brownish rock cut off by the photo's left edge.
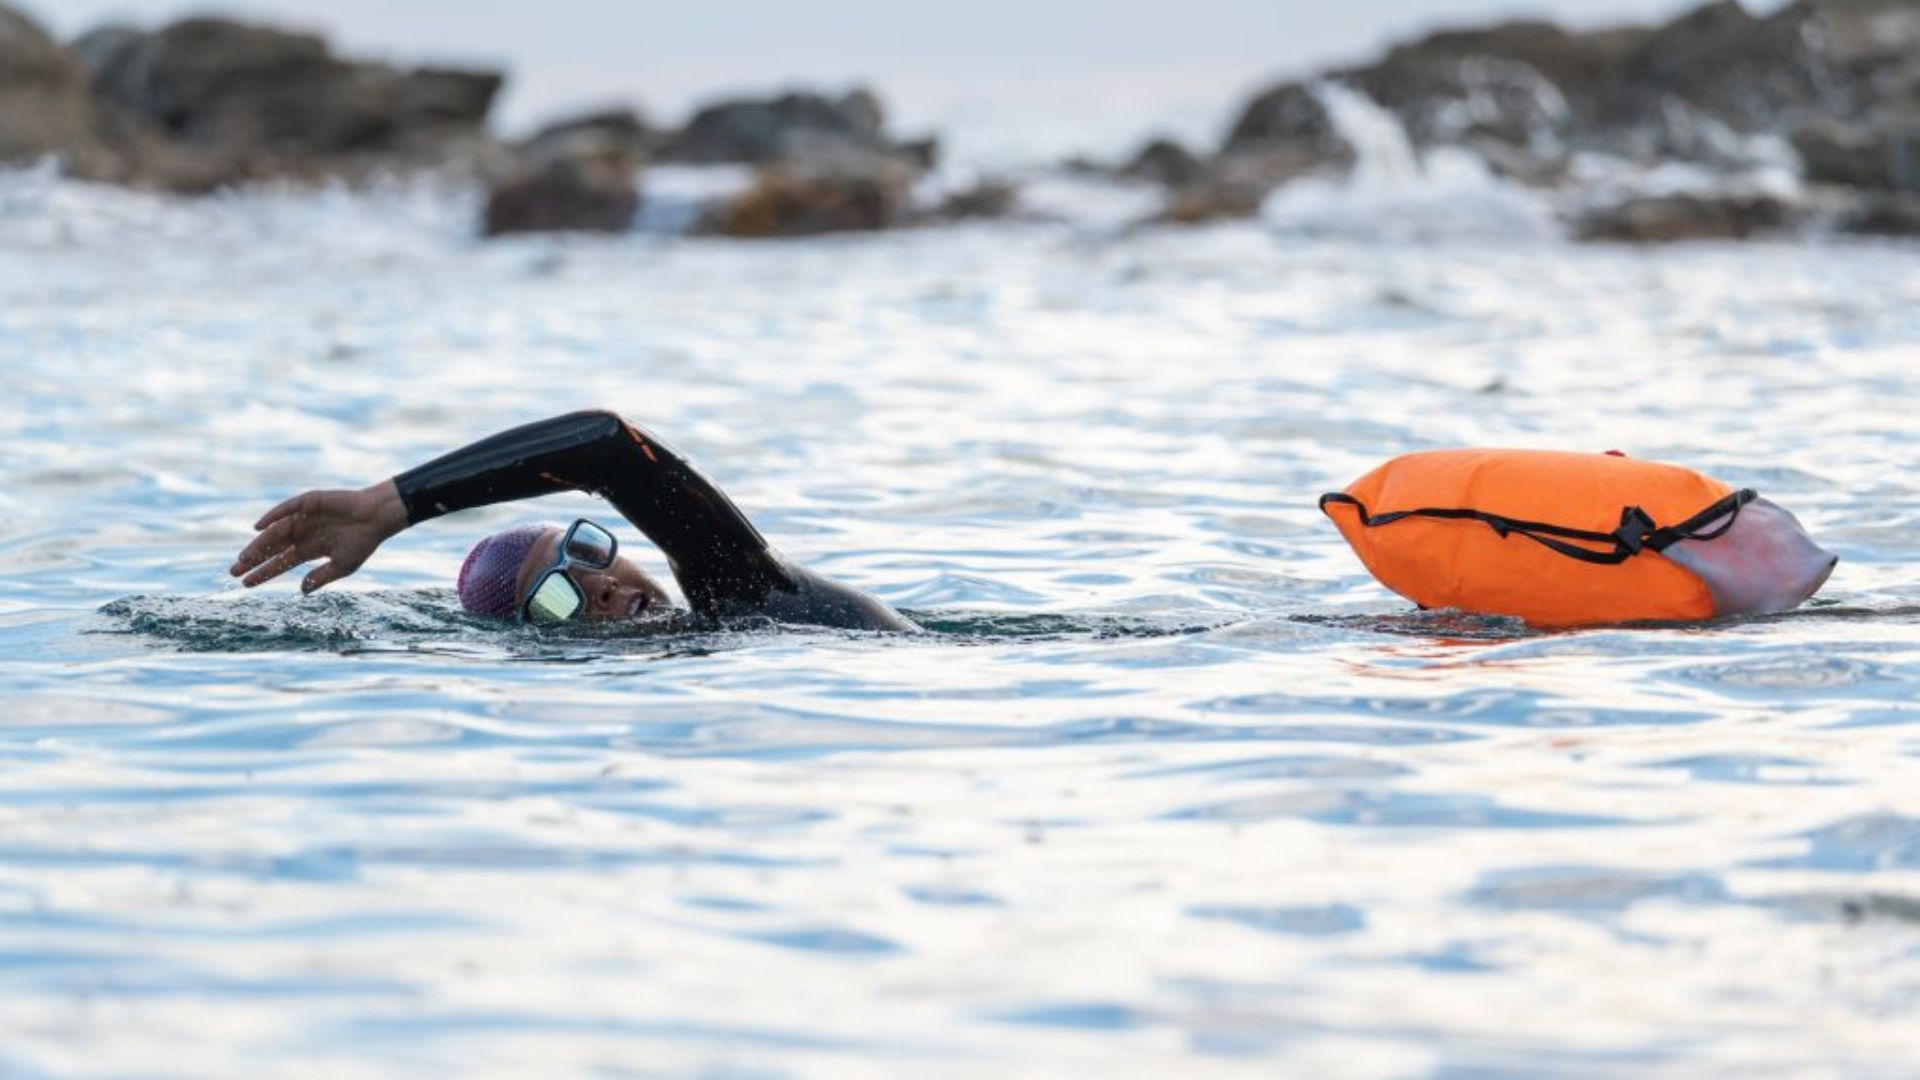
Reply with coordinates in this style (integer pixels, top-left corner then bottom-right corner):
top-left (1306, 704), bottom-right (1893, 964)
top-left (0, 4), bottom-right (94, 163)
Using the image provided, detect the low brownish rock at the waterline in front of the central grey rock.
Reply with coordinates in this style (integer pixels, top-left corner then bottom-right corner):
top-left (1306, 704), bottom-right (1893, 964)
top-left (695, 158), bottom-right (914, 238)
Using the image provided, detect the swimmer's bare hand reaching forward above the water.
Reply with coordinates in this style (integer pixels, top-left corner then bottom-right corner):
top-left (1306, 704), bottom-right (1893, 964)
top-left (227, 480), bottom-right (407, 592)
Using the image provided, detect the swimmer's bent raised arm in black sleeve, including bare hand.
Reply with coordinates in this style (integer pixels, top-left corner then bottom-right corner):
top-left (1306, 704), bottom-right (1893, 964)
top-left (232, 409), bottom-right (914, 630)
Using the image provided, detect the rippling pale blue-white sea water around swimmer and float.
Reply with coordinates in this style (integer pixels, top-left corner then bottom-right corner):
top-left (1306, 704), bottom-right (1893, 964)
top-left (0, 161), bottom-right (1920, 1080)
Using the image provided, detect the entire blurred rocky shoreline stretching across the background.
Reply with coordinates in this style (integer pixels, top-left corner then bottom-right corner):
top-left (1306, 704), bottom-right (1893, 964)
top-left (0, 0), bottom-right (1920, 242)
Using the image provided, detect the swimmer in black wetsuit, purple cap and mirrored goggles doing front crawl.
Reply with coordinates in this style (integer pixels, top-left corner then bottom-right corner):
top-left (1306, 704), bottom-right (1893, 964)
top-left (228, 411), bottom-right (918, 630)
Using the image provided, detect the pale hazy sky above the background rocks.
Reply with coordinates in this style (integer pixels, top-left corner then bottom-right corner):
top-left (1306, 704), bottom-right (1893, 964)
top-left (30, 0), bottom-right (1778, 161)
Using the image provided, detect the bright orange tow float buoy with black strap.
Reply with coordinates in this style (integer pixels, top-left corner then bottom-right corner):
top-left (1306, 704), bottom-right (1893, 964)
top-left (1319, 450), bottom-right (1839, 626)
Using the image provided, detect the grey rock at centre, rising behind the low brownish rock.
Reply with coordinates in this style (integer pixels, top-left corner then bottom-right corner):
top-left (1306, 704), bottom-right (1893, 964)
top-left (660, 90), bottom-right (887, 165)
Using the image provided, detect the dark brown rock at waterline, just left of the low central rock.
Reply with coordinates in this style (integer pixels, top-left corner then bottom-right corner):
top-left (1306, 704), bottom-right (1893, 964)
top-left (482, 138), bottom-right (639, 236)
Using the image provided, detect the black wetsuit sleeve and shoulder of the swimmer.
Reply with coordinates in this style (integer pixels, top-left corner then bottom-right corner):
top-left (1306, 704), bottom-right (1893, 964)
top-left (394, 411), bottom-right (916, 630)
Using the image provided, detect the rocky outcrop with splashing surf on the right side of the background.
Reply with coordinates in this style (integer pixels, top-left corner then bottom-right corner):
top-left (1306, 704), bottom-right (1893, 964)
top-left (1121, 0), bottom-right (1920, 240)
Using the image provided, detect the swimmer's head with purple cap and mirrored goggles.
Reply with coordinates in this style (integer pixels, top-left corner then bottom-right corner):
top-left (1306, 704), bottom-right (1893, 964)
top-left (459, 525), bottom-right (668, 619)
